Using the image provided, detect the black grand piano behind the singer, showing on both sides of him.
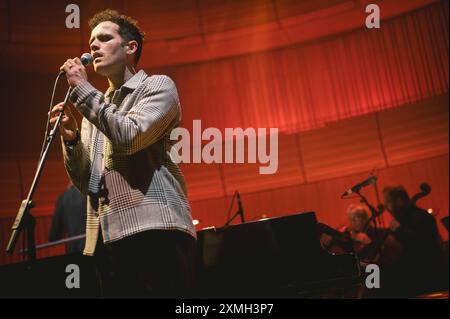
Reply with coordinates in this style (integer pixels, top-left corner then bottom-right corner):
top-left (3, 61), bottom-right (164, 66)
top-left (0, 212), bottom-right (361, 298)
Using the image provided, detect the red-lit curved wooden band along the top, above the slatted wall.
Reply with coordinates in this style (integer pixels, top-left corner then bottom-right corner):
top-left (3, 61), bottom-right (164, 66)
top-left (0, 0), bottom-right (437, 72)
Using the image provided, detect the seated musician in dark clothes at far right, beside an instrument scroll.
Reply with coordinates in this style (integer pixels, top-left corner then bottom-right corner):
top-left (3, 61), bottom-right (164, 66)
top-left (382, 186), bottom-right (448, 293)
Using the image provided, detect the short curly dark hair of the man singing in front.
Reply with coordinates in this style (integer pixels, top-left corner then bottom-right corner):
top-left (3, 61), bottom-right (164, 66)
top-left (89, 9), bottom-right (145, 64)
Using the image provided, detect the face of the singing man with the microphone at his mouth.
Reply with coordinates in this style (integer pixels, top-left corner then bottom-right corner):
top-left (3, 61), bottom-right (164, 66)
top-left (89, 21), bottom-right (127, 76)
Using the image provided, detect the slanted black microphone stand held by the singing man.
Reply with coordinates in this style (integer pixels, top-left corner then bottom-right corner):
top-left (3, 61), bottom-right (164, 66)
top-left (6, 88), bottom-right (72, 262)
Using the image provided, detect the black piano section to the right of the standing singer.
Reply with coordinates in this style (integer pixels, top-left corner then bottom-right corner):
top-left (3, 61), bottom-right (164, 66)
top-left (197, 212), bottom-right (361, 298)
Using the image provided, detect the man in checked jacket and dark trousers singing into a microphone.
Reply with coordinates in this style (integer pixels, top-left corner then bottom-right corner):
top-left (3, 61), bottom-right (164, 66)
top-left (51, 9), bottom-right (196, 297)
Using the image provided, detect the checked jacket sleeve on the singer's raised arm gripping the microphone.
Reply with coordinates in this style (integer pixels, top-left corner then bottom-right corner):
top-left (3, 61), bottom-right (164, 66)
top-left (67, 75), bottom-right (181, 155)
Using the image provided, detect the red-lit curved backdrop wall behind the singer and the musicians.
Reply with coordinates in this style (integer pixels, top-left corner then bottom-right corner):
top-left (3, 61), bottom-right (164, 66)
top-left (0, 1), bottom-right (449, 264)
